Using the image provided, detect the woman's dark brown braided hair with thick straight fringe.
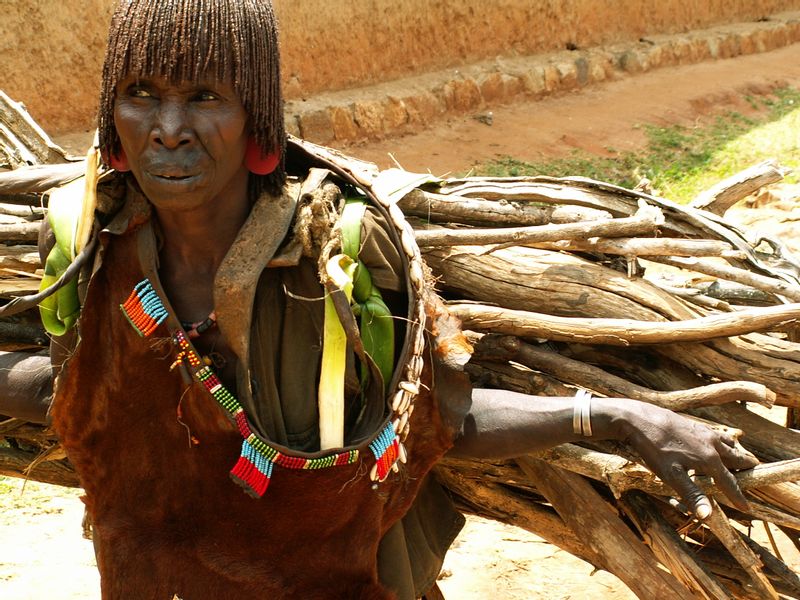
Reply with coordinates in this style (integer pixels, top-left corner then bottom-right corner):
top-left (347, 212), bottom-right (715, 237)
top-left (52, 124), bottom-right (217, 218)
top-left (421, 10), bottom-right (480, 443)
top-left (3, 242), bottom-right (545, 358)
top-left (98, 0), bottom-right (286, 197)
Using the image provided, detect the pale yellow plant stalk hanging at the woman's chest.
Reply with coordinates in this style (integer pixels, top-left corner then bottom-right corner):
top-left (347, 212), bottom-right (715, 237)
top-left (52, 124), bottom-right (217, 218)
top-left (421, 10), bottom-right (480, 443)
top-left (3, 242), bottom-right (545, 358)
top-left (317, 254), bottom-right (356, 450)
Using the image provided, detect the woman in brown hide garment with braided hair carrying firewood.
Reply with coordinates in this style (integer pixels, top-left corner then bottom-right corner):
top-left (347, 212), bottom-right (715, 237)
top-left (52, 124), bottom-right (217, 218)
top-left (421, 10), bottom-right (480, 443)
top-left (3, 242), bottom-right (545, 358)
top-left (15, 0), bottom-right (756, 600)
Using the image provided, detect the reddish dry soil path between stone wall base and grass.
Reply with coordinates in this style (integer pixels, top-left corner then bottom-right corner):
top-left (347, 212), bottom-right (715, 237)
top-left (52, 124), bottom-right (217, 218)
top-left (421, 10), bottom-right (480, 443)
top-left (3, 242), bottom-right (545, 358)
top-left (347, 44), bottom-right (800, 175)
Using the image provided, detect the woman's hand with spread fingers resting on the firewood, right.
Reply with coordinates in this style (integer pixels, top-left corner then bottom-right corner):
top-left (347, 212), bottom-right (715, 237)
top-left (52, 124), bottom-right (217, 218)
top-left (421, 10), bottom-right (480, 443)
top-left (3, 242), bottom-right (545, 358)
top-left (620, 400), bottom-right (759, 519)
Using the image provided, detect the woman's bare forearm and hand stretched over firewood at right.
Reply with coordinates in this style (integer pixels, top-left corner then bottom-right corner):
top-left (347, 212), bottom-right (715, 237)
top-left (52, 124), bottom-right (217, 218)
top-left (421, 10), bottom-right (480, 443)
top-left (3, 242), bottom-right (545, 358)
top-left (450, 389), bottom-right (758, 518)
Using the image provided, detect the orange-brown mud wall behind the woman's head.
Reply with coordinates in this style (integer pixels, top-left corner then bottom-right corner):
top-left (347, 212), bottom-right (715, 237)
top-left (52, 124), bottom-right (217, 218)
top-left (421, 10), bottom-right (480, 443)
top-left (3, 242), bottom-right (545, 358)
top-left (0, 0), bottom-right (800, 134)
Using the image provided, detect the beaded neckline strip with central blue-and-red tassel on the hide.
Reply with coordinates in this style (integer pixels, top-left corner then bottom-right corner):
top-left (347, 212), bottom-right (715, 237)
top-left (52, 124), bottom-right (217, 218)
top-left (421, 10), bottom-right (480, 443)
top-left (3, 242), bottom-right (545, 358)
top-left (174, 331), bottom-right (362, 497)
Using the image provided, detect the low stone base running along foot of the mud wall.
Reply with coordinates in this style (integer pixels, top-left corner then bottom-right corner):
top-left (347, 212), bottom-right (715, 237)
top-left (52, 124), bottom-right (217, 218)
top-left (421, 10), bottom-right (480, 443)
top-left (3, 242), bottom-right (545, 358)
top-left (286, 13), bottom-right (800, 144)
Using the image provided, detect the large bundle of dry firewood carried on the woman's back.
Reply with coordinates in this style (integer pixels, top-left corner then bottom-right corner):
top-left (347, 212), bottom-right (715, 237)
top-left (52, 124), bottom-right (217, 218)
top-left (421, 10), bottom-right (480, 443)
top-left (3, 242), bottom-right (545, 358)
top-left (0, 91), bottom-right (800, 599)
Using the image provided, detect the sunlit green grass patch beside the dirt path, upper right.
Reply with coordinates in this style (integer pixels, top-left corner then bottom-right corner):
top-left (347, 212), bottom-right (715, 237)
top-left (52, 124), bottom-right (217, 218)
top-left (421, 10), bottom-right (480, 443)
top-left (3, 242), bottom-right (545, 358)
top-left (473, 88), bottom-right (800, 202)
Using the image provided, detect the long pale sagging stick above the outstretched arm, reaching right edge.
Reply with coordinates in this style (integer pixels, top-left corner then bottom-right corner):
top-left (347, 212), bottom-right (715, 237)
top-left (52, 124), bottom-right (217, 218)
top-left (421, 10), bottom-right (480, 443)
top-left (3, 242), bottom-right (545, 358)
top-left (448, 302), bottom-right (800, 346)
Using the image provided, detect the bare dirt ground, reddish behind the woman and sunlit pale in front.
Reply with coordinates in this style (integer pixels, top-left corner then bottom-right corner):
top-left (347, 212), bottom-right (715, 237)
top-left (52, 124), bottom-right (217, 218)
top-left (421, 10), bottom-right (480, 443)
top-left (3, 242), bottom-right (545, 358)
top-left (0, 45), bottom-right (800, 600)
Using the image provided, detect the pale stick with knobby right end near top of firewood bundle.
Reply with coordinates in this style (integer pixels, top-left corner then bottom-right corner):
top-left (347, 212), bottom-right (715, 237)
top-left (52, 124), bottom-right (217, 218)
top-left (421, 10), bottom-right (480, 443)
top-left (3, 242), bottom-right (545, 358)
top-left (414, 207), bottom-right (663, 246)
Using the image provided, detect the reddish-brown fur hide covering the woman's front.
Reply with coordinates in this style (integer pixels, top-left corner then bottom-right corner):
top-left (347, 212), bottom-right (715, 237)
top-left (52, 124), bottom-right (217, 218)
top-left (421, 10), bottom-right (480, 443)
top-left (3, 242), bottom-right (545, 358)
top-left (53, 223), bottom-right (460, 600)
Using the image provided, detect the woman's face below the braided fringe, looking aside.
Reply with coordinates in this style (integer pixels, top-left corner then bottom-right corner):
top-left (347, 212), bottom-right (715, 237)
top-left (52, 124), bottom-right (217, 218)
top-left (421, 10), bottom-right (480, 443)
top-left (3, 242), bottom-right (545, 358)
top-left (114, 76), bottom-right (249, 216)
